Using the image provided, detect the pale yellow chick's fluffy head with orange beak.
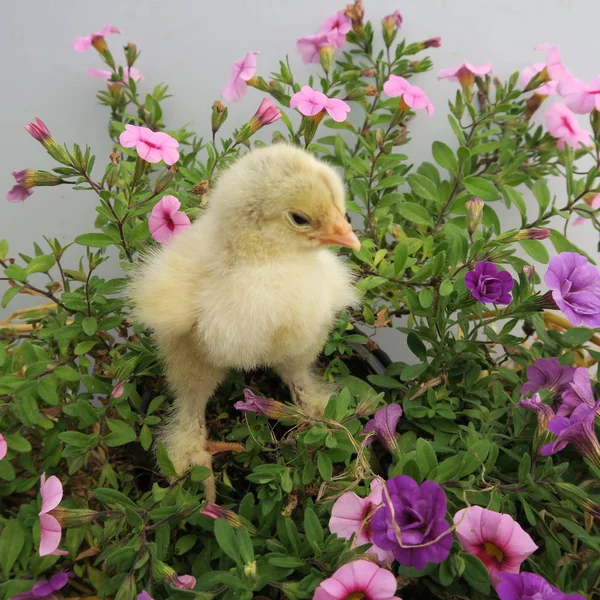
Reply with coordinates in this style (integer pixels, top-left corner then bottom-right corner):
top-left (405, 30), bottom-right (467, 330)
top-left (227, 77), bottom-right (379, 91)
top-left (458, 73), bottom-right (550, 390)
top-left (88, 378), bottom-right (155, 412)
top-left (211, 144), bottom-right (360, 250)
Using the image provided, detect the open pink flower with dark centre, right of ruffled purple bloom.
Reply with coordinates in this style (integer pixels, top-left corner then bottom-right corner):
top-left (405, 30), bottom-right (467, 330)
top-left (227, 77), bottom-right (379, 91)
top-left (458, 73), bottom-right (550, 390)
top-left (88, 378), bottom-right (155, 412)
top-left (454, 506), bottom-right (538, 583)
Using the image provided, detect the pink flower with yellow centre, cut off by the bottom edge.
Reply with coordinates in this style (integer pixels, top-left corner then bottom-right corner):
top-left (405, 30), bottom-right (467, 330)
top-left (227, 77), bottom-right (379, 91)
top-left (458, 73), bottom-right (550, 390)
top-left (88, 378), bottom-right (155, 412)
top-left (313, 560), bottom-right (400, 600)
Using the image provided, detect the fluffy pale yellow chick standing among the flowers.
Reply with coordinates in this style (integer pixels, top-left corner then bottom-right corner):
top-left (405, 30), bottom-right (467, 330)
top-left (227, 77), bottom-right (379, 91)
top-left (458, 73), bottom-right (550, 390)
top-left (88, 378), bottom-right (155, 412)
top-left (130, 144), bottom-right (360, 500)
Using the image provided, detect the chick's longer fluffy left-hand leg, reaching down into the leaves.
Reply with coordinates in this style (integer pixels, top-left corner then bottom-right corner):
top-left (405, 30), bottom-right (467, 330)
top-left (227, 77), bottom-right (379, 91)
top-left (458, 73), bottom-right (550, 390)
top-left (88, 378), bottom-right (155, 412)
top-left (160, 337), bottom-right (228, 502)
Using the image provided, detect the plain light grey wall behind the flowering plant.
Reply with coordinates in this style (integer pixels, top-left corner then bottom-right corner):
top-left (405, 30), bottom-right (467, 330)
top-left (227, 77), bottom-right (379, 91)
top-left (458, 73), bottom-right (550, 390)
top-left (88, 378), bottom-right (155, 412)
top-left (0, 0), bottom-right (600, 354)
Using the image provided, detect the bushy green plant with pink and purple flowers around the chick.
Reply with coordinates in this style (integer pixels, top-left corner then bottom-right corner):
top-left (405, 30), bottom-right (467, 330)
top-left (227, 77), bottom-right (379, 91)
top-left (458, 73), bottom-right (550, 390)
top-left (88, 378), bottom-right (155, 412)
top-left (0, 0), bottom-right (600, 600)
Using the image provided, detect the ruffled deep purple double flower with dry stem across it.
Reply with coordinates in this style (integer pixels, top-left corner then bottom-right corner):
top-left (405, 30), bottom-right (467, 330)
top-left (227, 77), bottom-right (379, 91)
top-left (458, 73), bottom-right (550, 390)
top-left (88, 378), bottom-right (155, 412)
top-left (371, 475), bottom-right (452, 569)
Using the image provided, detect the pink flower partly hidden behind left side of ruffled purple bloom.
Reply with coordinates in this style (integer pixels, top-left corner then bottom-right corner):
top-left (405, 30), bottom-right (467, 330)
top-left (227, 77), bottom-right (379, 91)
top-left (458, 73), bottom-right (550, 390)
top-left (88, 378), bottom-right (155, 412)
top-left (329, 479), bottom-right (394, 564)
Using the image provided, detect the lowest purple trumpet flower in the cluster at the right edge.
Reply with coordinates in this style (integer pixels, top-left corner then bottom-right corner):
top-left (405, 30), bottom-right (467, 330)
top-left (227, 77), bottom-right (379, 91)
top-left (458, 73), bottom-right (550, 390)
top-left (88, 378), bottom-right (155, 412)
top-left (540, 400), bottom-right (600, 468)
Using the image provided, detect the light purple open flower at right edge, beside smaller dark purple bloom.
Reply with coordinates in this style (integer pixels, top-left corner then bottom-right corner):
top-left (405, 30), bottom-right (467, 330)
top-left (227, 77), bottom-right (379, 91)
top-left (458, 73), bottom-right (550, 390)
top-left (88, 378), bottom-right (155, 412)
top-left (544, 252), bottom-right (600, 327)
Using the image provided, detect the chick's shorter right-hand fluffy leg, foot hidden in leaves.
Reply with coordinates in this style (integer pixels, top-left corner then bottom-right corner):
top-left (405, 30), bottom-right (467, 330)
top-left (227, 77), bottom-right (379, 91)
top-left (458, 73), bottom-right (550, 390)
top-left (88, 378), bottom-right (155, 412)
top-left (275, 346), bottom-right (337, 417)
